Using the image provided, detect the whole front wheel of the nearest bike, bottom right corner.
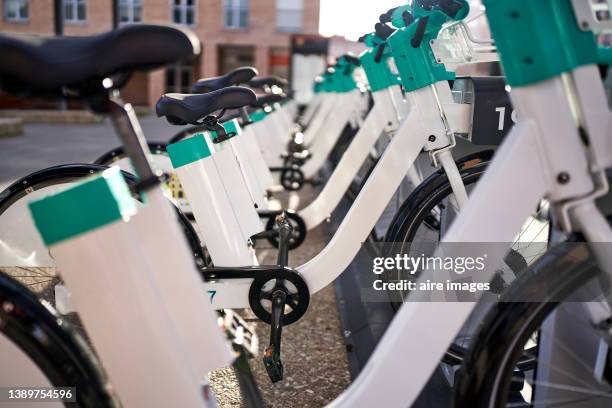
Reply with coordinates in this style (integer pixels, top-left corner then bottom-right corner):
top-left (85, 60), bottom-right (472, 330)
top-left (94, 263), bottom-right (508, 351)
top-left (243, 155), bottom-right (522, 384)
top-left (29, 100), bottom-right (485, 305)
top-left (455, 243), bottom-right (612, 408)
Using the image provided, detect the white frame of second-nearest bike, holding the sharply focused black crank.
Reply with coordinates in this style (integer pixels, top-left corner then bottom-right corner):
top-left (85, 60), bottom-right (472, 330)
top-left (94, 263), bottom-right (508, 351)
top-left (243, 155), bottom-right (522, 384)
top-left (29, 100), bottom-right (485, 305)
top-left (204, 81), bottom-right (470, 309)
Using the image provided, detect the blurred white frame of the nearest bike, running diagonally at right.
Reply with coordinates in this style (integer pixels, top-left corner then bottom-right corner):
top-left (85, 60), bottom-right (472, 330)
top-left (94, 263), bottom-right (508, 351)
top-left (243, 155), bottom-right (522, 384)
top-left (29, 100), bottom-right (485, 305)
top-left (331, 66), bottom-right (612, 407)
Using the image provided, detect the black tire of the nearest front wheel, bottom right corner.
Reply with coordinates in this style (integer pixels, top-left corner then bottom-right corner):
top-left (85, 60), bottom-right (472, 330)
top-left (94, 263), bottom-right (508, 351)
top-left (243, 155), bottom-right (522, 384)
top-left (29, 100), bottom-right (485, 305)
top-left (454, 243), bottom-right (600, 408)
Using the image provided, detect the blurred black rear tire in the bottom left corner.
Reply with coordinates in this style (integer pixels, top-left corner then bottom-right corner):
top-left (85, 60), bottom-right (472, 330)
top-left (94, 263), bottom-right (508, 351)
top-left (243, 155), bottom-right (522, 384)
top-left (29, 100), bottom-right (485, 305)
top-left (0, 272), bottom-right (116, 407)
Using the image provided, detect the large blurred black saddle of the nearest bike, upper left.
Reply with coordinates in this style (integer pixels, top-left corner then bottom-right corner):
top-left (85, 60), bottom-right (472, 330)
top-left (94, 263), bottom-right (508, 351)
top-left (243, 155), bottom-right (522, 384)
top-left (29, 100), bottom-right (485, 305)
top-left (0, 24), bottom-right (201, 94)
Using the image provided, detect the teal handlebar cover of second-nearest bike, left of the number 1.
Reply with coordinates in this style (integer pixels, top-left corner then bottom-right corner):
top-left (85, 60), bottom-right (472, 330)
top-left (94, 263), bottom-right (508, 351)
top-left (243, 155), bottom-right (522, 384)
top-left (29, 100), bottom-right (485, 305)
top-left (387, 0), bottom-right (470, 92)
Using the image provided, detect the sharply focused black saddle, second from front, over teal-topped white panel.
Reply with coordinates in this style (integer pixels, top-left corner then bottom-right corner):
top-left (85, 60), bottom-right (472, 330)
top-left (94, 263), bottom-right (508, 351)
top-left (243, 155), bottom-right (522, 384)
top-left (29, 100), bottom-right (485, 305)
top-left (155, 86), bottom-right (257, 125)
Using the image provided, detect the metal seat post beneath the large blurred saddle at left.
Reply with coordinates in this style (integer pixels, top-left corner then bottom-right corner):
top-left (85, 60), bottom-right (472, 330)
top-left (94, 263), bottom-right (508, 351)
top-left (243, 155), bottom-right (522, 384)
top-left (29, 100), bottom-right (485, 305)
top-left (108, 91), bottom-right (159, 189)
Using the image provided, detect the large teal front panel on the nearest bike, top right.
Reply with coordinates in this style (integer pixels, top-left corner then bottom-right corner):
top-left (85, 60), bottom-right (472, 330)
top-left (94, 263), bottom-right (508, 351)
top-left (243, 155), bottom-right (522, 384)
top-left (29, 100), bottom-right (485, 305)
top-left (484, 0), bottom-right (600, 86)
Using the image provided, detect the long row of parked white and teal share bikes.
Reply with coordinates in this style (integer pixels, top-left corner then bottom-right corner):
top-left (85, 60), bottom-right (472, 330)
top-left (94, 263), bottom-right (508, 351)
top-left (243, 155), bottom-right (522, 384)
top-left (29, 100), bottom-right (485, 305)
top-left (0, 0), bottom-right (612, 407)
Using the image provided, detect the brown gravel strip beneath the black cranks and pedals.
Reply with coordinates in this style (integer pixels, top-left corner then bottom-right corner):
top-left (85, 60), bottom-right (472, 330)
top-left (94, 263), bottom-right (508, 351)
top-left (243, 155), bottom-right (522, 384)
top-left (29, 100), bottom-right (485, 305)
top-left (211, 186), bottom-right (351, 408)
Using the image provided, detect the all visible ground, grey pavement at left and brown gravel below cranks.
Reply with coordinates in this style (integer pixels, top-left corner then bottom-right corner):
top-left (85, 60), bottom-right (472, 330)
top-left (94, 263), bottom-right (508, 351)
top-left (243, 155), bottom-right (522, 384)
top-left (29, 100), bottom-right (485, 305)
top-left (0, 117), bottom-right (350, 408)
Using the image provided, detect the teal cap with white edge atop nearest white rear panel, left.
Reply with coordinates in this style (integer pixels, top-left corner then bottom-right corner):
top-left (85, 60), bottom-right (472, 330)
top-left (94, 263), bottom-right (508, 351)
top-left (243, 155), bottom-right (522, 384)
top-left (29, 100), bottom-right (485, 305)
top-left (29, 167), bottom-right (137, 246)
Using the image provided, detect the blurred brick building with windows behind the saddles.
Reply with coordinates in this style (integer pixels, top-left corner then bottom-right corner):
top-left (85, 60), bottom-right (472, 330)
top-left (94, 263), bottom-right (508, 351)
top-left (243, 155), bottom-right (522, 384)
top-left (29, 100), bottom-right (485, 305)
top-left (0, 0), bottom-right (319, 107)
